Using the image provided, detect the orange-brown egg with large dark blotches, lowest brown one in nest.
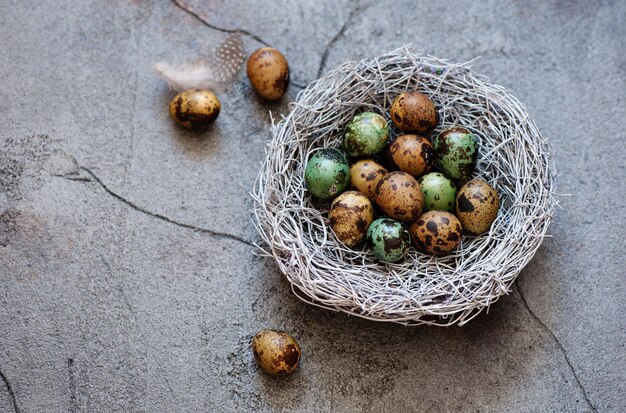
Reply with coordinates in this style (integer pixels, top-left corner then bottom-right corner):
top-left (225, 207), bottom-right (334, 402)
top-left (409, 211), bottom-right (463, 255)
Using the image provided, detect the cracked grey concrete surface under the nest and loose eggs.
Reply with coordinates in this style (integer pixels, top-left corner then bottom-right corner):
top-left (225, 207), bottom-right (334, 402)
top-left (0, 0), bottom-right (626, 413)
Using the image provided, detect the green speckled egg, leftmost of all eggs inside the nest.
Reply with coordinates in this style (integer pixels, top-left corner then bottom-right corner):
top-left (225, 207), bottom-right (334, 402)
top-left (304, 148), bottom-right (350, 199)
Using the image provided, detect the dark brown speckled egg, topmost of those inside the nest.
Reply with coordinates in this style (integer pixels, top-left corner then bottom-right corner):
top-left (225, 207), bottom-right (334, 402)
top-left (390, 92), bottom-right (439, 133)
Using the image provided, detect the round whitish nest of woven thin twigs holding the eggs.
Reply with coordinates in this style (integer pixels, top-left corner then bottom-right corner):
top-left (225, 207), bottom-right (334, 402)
top-left (253, 46), bottom-right (557, 326)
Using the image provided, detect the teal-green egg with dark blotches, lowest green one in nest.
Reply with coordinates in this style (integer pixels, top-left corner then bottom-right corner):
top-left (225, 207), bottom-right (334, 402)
top-left (367, 218), bottom-right (411, 262)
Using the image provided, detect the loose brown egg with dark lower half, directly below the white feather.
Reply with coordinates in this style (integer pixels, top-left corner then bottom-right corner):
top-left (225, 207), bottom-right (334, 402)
top-left (170, 89), bottom-right (222, 130)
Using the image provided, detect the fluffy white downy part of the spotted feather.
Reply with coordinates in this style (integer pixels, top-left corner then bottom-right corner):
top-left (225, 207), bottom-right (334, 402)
top-left (154, 62), bottom-right (218, 92)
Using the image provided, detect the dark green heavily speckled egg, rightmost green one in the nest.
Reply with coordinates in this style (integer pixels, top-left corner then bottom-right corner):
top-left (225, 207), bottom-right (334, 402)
top-left (433, 126), bottom-right (478, 180)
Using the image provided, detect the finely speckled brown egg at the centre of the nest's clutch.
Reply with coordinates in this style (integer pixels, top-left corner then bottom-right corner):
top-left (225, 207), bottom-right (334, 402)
top-left (375, 171), bottom-right (424, 222)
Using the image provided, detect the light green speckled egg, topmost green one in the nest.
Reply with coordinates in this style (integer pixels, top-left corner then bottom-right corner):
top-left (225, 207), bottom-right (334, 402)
top-left (343, 112), bottom-right (389, 156)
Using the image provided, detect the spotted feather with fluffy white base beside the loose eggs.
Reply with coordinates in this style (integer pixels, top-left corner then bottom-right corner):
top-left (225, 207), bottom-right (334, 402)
top-left (154, 35), bottom-right (246, 91)
